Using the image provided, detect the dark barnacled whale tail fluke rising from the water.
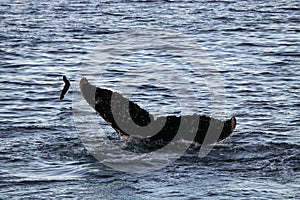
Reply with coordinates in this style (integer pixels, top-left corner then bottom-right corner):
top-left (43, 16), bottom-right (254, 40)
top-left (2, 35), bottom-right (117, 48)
top-left (80, 78), bottom-right (236, 144)
